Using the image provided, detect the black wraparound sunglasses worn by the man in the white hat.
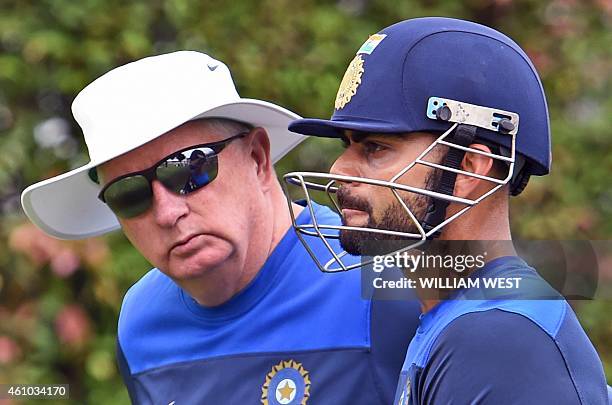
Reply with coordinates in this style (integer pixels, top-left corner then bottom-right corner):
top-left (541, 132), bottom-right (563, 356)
top-left (98, 132), bottom-right (248, 218)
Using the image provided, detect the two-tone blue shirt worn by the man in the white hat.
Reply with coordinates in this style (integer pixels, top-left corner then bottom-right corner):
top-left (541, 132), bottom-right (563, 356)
top-left (118, 202), bottom-right (420, 405)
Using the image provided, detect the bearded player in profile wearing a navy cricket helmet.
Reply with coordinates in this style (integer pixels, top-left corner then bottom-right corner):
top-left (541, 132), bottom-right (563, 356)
top-left (287, 18), bottom-right (607, 405)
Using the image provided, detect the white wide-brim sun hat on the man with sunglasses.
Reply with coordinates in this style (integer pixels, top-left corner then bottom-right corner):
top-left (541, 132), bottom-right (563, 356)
top-left (21, 51), bottom-right (306, 239)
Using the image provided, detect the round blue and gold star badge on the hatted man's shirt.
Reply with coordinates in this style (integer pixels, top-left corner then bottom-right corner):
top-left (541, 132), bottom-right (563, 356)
top-left (261, 360), bottom-right (310, 405)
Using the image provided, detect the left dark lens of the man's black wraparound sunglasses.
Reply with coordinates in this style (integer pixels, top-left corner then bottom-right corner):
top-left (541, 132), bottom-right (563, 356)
top-left (104, 175), bottom-right (152, 218)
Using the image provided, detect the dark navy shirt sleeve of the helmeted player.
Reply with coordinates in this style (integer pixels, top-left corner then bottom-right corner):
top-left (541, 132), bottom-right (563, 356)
top-left (418, 309), bottom-right (580, 405)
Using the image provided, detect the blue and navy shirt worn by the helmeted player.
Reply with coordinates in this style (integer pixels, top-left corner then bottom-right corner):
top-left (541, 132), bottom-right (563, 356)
top-left (394, 257), bottom-right (608, 405)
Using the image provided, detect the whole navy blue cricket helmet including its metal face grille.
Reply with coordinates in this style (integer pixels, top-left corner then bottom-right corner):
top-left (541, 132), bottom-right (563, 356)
top-left (284, 17), bottom-right (551, 271)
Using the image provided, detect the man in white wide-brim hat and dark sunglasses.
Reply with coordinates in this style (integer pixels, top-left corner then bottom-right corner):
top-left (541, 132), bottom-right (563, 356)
top-left (23, 52), bottom-right (419, 404)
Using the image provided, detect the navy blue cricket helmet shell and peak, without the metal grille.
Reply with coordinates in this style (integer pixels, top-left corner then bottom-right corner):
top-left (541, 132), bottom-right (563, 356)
top-left (289, 17), bottom-right (551, 192)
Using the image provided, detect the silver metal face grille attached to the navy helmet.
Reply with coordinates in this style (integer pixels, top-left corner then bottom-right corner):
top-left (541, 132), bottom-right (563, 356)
top-left (283, 118), bottom-right (516, 272)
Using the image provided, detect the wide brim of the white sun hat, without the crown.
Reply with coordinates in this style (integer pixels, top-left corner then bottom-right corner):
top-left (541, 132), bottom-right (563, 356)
top-left (21, 99), bottom-right (306, 239)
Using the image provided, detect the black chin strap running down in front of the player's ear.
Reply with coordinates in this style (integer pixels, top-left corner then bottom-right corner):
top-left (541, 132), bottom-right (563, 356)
top-left (423, 124), bottom-right (476, 240)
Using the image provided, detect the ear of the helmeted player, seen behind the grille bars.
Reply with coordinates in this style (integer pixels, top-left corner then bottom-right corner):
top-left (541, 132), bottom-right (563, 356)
top-left (454, 143), bottom-right (495, 198)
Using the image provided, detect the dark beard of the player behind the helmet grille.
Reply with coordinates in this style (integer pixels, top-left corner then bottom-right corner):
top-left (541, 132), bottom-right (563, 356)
top-left (337, 172), bottom-right (439, 256)
